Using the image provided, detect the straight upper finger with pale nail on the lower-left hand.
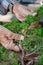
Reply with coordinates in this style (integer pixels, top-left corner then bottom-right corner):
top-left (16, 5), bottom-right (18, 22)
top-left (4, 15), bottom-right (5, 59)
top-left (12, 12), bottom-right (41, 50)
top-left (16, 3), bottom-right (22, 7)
top-left (0, 25), bottom-right (24, 40)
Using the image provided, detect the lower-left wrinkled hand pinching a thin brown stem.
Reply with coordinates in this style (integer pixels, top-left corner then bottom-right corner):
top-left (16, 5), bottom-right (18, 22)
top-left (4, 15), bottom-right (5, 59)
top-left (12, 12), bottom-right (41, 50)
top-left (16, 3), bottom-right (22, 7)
top-left (0, 25), bottom-right (24, 52)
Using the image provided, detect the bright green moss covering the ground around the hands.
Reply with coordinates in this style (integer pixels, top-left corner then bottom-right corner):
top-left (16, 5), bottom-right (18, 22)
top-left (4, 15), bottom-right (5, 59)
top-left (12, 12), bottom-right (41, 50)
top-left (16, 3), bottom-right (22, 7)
top-left (0, 6), bottom-right (43, 65)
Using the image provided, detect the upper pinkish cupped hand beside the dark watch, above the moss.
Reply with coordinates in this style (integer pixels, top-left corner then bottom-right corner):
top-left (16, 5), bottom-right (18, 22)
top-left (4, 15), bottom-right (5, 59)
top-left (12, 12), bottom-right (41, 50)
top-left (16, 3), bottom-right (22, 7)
top-left (13, 3), bottom-right (37, 21)
